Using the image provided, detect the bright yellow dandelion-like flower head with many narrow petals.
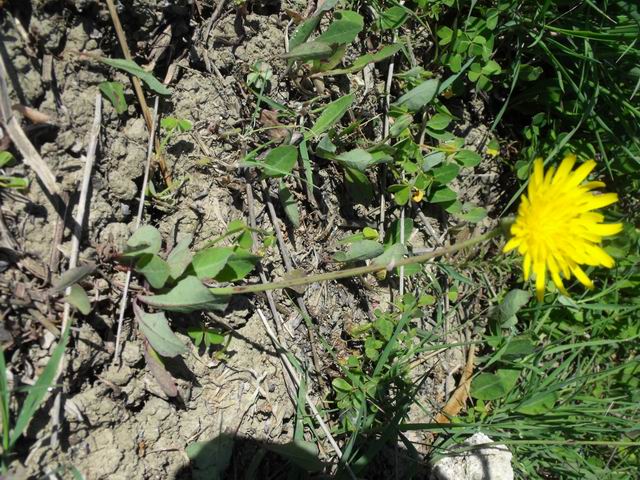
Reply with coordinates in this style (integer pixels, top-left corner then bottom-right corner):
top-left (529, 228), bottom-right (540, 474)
top-left (504, 154), bottom-right (622, 301)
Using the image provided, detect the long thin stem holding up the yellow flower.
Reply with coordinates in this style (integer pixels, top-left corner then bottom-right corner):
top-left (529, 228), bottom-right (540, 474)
top-left (209, 226), bottom-right (503, 295)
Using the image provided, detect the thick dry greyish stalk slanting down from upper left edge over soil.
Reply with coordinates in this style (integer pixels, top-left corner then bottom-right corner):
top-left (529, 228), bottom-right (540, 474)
top-left (0, 53), bottom-right (62, 195)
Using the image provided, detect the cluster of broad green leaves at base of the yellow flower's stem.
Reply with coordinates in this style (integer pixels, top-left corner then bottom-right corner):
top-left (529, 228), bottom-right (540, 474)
top-left (121, 220), bottom-right (273, 396)
